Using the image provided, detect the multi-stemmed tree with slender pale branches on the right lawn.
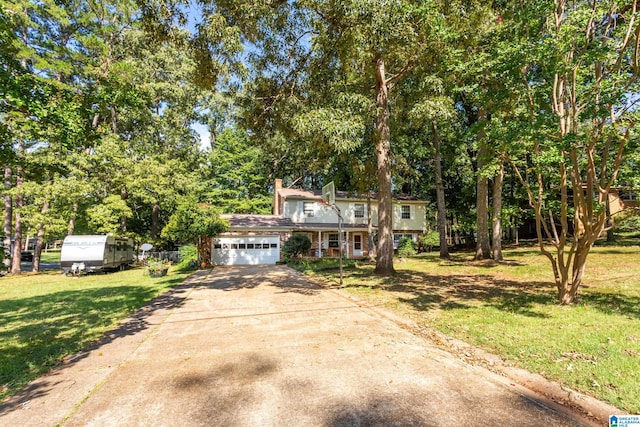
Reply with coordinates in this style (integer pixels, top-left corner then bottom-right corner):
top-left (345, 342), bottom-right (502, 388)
top-left (509, 0), bottom-right (640, 304)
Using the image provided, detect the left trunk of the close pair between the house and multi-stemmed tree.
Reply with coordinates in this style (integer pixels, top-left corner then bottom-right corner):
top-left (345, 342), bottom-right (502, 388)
top-left (474, 108), bottom-right (491, 260)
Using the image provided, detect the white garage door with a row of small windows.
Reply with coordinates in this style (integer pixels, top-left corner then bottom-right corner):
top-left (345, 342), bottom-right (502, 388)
top-left (213, 236), bottom-right (280, 265)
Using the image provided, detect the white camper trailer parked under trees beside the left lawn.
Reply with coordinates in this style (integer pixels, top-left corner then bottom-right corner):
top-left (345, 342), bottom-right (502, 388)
top-left (60, 235), bottom-right (133, 274)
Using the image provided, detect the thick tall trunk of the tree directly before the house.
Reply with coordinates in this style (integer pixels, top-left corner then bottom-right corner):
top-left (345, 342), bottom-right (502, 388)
top-left (374, 56), bottom-right (395, 276)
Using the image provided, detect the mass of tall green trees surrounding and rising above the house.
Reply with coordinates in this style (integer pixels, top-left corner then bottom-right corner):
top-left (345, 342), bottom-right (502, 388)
top-left (0, 0), bottom-right (640, 303)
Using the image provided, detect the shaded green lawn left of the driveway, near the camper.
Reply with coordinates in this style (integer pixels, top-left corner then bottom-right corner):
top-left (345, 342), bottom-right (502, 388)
top-left (0, 269), bottom-right (188, 401)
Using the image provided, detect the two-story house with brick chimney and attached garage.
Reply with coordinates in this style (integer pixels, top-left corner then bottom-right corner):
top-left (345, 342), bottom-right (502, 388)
top-left (212, 179), bottom-right (426, 265)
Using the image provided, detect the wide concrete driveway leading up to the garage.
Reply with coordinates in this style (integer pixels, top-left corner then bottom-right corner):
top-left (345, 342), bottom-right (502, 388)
top-left (0, 266), bottom-right (591, 426)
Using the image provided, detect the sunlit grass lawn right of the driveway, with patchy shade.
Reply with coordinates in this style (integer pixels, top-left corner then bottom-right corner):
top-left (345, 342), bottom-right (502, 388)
top-left (298, 246), bottom-right (640, 413)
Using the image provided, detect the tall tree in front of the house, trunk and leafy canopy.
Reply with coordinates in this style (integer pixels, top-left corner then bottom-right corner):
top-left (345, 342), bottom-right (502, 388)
top-left (218, 0), bottom-right (439, 275)
